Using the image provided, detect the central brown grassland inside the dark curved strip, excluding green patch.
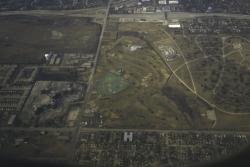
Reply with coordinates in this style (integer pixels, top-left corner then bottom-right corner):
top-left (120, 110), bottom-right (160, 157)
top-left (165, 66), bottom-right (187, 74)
top-left (91, 36), bottom-right (184, 128)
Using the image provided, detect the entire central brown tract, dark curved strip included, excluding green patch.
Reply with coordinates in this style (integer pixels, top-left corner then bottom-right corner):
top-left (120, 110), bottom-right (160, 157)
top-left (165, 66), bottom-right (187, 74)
top-left (88, 23), bottom-right (221, 129)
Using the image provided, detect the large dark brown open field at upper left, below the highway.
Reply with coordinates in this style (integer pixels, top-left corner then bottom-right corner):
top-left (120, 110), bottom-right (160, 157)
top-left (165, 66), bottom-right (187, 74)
top-left (0, 15), bottom-right (101, 64)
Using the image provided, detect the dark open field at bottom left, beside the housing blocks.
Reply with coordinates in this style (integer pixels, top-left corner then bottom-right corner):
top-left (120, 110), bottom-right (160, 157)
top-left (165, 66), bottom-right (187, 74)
top-left (0, 131), bottom-right (72, 161)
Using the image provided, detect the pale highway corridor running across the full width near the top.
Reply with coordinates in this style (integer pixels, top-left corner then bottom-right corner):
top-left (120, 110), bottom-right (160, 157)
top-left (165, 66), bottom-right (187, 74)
top-left (0, 7), bottom-right (250, 21)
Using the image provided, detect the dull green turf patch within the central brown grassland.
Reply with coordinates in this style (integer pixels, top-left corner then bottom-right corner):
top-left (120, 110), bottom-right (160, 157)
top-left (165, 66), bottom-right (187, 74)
top-left (97, 73), bottom-right (129, 96)
